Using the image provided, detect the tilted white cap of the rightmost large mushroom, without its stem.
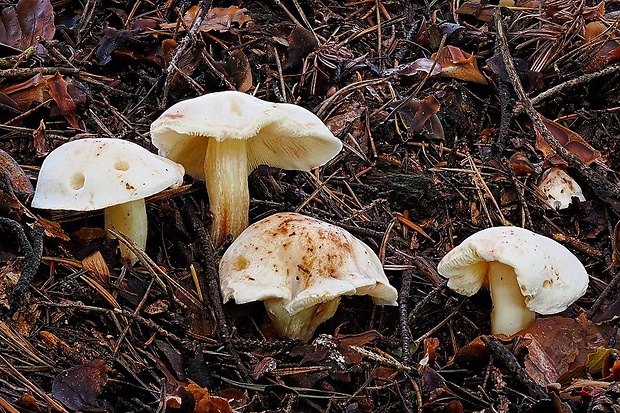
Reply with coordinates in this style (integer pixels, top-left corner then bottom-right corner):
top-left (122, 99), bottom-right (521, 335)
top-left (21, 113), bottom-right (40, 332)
top-left (437, 227), bottom-right (589, 314)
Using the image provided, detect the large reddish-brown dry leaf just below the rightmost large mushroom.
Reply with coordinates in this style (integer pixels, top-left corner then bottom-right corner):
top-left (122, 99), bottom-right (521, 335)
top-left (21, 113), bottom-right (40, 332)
top-left (514, 314), bottom-right (611, 386)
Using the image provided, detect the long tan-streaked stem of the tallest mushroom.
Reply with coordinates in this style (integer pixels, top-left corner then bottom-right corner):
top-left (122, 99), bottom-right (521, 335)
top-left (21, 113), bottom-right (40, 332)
top-left (204, 139), bottom-right (250, 247)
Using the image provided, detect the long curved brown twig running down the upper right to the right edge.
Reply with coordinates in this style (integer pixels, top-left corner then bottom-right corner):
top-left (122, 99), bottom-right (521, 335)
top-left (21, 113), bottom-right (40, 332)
top-left (493, 8), bottom-right (620, 212)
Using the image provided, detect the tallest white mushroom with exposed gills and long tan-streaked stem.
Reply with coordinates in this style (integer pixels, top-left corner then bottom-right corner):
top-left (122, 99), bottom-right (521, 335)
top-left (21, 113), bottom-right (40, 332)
top-left (151, 91), bottom-right (342, 246)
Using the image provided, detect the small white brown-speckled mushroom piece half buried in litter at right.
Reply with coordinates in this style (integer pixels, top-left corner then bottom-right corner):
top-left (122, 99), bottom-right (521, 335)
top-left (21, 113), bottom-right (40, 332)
top-left (538, 166), bottom-right (586, 210)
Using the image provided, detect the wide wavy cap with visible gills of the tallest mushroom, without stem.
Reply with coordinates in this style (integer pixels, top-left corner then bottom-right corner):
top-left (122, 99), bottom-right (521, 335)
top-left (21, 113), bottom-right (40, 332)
top-left (151, 91), bottom-right (342, 180)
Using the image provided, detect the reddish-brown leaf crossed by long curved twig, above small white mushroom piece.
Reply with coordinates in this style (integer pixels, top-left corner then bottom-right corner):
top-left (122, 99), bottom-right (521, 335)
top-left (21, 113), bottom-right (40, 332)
top-left (536, 117), bottom-right (601, 166)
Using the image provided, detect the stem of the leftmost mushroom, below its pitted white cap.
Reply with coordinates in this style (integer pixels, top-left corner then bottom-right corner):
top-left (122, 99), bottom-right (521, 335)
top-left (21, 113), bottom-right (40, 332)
top-left (104, 198), bottom-right (148, 265)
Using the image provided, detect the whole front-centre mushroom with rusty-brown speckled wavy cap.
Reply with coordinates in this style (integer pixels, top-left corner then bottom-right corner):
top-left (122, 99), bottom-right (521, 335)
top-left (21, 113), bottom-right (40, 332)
top-left (220, 212), bottom-right (398, 341)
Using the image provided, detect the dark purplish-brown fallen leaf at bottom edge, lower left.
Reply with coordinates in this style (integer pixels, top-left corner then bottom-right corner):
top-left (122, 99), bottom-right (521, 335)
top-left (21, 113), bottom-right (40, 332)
top-left (52, 360), bottom-right (112, 412)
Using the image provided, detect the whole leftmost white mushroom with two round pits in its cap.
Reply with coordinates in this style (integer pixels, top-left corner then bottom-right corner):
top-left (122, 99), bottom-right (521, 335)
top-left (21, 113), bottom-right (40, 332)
top-left (32, 138), bottom-right (184, 264)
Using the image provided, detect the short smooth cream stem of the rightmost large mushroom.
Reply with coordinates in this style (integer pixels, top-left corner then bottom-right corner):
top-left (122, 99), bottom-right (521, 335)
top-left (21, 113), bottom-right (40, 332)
top-left (487, 261), bottom-right (536, 336)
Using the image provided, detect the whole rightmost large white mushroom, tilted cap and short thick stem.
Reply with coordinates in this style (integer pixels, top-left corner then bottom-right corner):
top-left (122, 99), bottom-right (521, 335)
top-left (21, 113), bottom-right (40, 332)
top-left (437, 227), bottom-right (589, 335)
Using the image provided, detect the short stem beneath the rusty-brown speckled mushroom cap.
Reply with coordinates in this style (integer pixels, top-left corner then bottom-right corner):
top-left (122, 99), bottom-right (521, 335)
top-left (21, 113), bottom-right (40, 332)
top-left (263, 297), bottom-right (340, 342)
